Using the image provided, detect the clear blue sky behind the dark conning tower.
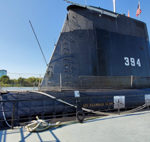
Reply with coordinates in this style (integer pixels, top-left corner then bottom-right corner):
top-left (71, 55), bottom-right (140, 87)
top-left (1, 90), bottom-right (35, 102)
top-left (0, 0), bottom-right (150, 78)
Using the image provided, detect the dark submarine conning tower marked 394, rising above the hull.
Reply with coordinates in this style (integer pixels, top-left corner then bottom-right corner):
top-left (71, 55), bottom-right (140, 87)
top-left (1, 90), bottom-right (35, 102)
top-left (41, 5), bottom-right (150, 91)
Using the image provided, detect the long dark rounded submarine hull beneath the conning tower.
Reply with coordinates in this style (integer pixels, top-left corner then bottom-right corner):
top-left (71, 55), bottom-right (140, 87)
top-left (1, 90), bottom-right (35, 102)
top-left (0, 88), bottom-right (150, 127)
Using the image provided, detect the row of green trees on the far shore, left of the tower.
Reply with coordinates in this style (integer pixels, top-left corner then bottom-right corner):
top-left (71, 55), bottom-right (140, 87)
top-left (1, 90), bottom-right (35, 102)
top-left (0, 75), bottom-right (42, 87)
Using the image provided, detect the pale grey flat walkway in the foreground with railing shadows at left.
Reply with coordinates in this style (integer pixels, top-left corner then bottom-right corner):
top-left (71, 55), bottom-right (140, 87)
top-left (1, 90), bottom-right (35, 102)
top-left (0, 111), bottom-right (150, 142)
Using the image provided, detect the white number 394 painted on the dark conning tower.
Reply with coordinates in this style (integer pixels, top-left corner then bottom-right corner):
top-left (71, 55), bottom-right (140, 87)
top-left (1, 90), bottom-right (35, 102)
top-left (124, 57), bottom-right (141, 67)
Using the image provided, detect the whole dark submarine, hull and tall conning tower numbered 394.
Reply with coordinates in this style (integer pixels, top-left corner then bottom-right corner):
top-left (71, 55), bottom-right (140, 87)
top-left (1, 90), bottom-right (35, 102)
top-left (0, 3), bottom-right (150, 128)
